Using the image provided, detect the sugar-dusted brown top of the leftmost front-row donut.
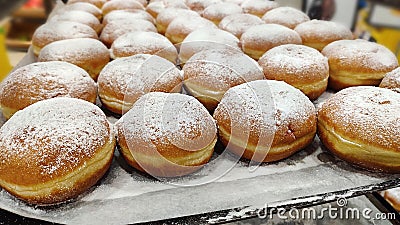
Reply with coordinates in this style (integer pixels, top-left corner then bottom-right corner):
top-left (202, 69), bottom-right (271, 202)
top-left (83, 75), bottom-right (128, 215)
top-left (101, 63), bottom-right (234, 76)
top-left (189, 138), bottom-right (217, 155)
top-left (0, 98), bottom-right (111, 182)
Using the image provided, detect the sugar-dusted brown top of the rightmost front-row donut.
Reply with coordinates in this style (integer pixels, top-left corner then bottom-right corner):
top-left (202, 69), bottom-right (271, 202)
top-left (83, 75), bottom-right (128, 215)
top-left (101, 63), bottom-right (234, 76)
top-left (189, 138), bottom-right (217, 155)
top-left (318, 86), bottom-right (400, 151)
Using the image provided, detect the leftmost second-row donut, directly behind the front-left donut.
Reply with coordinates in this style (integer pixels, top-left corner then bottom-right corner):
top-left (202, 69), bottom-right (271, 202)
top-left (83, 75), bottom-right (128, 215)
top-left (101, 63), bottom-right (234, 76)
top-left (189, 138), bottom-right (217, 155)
top-left (0, 61), bottom-right (97, 119)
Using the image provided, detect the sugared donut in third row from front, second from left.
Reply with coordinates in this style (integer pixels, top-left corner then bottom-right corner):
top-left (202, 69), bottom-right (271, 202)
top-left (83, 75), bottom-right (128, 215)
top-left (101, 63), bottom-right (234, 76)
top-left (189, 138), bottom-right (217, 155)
top-left (110, 31), bottom-right (178, 64)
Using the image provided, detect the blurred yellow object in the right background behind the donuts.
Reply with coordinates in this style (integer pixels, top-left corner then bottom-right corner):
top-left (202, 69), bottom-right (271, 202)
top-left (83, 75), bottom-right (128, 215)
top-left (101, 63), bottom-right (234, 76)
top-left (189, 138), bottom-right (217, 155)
top-left (355, 9), bottom-right (400, 61)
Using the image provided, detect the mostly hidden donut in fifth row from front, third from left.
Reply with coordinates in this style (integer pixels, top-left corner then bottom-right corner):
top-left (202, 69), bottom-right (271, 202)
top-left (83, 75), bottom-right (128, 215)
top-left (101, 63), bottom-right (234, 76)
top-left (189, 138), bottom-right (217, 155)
top-left (156, 8), bottom-right (200, 34)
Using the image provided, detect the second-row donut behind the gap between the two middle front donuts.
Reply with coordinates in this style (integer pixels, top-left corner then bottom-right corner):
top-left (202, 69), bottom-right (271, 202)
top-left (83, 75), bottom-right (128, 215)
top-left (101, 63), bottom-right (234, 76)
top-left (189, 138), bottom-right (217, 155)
top-left (182, 48), bottom-right (264, 111)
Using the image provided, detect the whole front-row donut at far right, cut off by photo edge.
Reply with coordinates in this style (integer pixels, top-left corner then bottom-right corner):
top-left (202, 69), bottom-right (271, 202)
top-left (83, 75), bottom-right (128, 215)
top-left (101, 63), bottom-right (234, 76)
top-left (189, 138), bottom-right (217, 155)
top-left (318, 86), bottom-right (400, 173)
